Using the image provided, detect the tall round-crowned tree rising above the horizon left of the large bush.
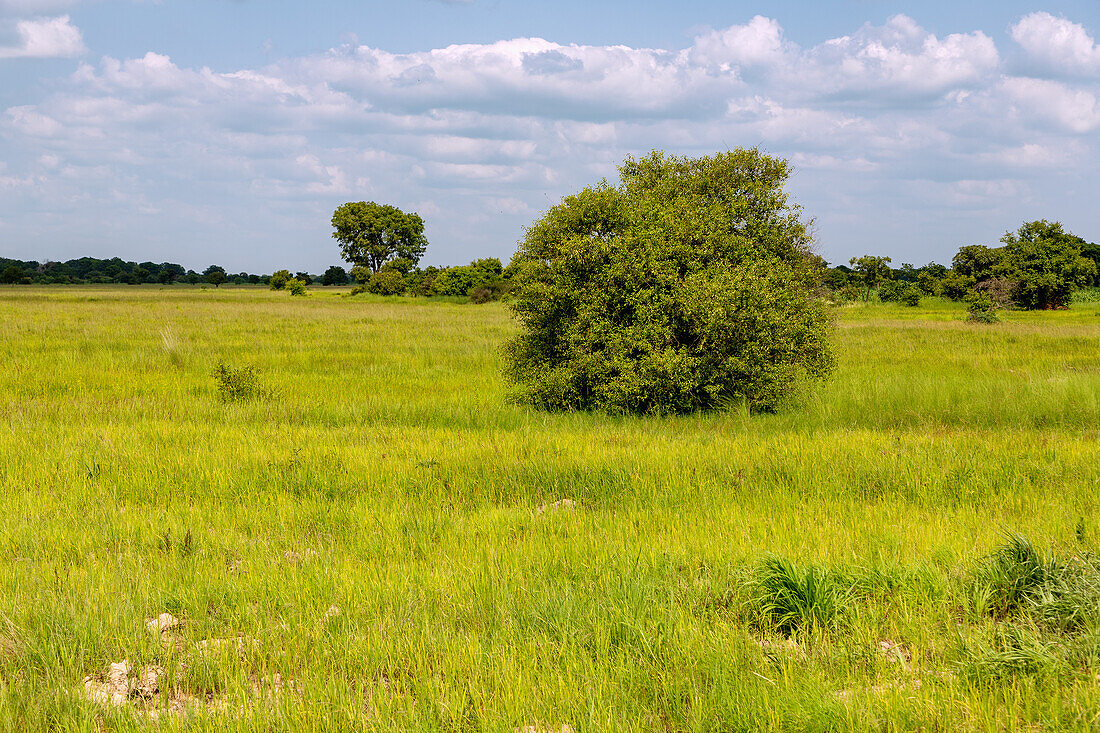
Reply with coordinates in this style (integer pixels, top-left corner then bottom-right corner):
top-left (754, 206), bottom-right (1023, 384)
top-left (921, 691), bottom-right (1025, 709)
top-left (332, 201), bottom-right (428, 272)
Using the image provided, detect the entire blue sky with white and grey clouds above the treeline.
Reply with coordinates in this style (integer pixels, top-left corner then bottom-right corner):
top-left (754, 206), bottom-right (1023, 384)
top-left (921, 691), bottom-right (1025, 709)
top-left (0, 0), bottom-right (1100, 272)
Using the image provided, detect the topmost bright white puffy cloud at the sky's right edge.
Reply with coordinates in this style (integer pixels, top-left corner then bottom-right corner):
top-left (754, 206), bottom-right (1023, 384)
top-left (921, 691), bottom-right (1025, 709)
top-left (1012, 12), bottom-right (1100, 76)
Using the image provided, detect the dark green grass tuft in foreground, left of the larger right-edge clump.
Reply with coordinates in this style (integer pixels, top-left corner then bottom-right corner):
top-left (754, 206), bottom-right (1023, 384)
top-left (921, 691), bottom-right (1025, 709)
top-left (748, 555), bottom-right (847, 635)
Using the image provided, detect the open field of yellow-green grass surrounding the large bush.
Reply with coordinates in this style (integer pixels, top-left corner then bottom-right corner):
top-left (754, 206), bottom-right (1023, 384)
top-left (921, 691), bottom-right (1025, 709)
top-left (0, 287), bottom-right (1100, 732)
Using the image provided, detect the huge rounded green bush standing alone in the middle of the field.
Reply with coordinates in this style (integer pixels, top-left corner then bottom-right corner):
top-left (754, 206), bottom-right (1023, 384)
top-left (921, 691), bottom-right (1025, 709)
top-left (507, 150), bottom-right (834, 413)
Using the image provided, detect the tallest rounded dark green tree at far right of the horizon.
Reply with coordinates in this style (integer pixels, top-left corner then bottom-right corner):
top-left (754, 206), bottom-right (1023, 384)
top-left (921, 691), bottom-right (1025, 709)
top-left (994, 219), bottom-right (1097, 309)
